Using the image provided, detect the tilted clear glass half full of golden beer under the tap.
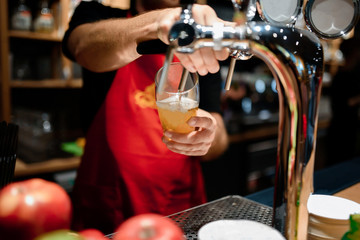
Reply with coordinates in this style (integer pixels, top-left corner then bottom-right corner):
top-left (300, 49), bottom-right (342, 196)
top-left (155, 62), bottom-right (199, 133)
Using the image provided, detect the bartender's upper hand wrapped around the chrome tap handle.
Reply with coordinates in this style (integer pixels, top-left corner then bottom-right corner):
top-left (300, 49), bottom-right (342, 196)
top-left (158, 4), bottom-right (234, 75)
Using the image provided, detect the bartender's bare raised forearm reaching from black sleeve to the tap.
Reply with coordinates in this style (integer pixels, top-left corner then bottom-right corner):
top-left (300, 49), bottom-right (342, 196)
top-left (68, 9), bottom-right (180, 72)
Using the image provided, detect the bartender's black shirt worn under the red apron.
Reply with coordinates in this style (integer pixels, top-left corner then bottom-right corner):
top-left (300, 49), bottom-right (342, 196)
top-left (62, 1), bottom-right (222, 132)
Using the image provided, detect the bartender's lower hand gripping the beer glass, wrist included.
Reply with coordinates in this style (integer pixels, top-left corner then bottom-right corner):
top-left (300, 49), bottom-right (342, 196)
top-left (162, 109), bottom-right (228, 160)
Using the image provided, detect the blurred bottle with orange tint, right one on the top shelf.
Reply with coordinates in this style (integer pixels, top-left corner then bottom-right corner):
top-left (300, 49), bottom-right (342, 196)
top-left (34, 0), bottom-right (54, 33)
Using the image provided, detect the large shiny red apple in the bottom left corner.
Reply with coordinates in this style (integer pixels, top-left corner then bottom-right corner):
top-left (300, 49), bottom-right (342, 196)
top-left (0, 178), bottom-right (72, 240)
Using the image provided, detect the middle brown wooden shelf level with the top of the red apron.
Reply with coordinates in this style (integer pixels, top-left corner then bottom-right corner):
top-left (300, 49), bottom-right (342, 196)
top-left (10, 79), bottom-right (82, 88)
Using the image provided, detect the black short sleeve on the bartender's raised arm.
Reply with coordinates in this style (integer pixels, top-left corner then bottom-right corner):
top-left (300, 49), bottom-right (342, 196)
top-left (62, 1), bottom-right (127, 61)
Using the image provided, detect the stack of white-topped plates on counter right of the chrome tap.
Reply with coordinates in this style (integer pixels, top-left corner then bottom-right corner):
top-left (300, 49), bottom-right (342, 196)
top-left (307, 194), bottom-right (360, 240)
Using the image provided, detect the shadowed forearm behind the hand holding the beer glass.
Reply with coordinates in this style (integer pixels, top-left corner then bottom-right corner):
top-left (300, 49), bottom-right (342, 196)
top-left (201, 113), bottom-right (229, 161)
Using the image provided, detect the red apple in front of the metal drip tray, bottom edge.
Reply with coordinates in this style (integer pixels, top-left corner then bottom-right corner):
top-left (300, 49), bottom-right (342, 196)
top-left (114, 213), bottom-right (185, 240)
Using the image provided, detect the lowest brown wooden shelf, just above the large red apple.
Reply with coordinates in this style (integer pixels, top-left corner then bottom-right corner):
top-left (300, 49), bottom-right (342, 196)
top-left (14, 157), bottom-right (81, 178)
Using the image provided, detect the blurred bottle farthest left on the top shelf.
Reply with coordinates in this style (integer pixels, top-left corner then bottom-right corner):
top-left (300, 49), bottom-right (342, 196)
top-left (11, 0), bottom-right (32, 31)
